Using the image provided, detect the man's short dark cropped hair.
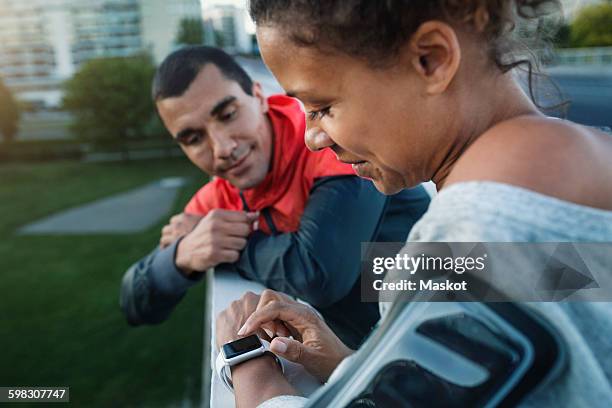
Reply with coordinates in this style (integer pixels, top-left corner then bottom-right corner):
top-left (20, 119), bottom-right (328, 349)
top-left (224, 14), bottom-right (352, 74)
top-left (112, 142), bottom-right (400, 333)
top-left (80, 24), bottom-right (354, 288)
top-left (151, 45), bottom-right (253, 102)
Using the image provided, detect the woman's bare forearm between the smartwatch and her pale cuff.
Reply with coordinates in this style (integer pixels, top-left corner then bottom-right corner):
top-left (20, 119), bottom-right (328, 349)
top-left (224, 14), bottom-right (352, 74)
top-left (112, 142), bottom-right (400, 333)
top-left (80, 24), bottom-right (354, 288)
top-left (232, 355), bottom-right (298, 408)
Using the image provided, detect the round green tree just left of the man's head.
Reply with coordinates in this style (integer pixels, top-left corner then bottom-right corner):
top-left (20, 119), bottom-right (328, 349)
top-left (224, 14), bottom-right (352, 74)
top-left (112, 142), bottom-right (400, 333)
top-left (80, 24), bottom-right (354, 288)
top-left (63, 55), bottom-right (155, 155)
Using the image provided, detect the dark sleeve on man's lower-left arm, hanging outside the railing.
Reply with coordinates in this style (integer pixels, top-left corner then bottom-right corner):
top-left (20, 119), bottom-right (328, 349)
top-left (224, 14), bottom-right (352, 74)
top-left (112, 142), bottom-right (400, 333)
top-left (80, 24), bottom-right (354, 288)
top-left (119, 240), bottom-right (203, 326)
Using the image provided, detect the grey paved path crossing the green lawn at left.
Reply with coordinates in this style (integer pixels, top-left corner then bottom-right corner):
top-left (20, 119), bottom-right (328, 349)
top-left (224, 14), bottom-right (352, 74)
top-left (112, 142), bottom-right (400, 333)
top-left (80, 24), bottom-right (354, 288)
top-left (18, 178), bottom-right (185, 234)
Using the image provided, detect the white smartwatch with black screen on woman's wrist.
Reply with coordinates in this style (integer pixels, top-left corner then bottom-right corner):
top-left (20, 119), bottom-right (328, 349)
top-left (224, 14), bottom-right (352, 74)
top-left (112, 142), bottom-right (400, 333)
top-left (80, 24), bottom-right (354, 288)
top-left (215, 334), bottom-right (285, 392)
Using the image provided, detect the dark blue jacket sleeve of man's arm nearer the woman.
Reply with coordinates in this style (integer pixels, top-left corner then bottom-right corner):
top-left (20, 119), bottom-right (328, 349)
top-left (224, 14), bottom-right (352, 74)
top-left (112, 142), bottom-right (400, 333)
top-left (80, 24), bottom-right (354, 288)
top-left (218, 176), bottom-right (387, 307)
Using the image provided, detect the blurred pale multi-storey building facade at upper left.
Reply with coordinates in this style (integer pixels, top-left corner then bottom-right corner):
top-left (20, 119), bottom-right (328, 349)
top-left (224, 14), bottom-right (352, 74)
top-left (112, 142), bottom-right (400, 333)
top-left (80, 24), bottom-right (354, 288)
top-left (0, 0), bottom-right (201, 107)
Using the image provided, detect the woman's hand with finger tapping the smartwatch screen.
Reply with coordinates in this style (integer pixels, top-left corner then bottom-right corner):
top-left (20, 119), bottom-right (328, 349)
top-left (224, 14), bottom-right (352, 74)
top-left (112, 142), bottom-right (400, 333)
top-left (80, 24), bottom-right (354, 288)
top-left (238, 290), bottom-right (353, 382)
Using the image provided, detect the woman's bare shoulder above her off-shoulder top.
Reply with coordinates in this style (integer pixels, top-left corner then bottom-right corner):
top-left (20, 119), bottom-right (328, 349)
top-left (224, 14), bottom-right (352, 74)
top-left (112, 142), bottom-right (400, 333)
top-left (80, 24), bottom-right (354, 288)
top-left (445, 115), bottom-right (612, 210)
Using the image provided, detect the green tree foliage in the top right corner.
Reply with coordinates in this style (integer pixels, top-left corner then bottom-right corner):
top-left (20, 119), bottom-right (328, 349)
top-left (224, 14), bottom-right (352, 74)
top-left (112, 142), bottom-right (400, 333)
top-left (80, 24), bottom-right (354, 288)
top-left (570, 1), bottom-right (612, 47)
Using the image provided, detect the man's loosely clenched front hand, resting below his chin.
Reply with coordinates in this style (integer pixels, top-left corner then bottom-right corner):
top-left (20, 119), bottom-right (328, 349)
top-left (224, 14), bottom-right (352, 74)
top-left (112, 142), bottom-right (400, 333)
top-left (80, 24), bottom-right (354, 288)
top-left (176, 209), bottom-right (259, 275)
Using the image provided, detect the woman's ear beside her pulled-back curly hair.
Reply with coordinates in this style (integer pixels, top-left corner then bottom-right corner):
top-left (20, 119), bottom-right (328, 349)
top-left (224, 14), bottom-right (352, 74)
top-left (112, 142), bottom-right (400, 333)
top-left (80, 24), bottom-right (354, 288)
top-left (403, 21), bottom-right (461, 95)
